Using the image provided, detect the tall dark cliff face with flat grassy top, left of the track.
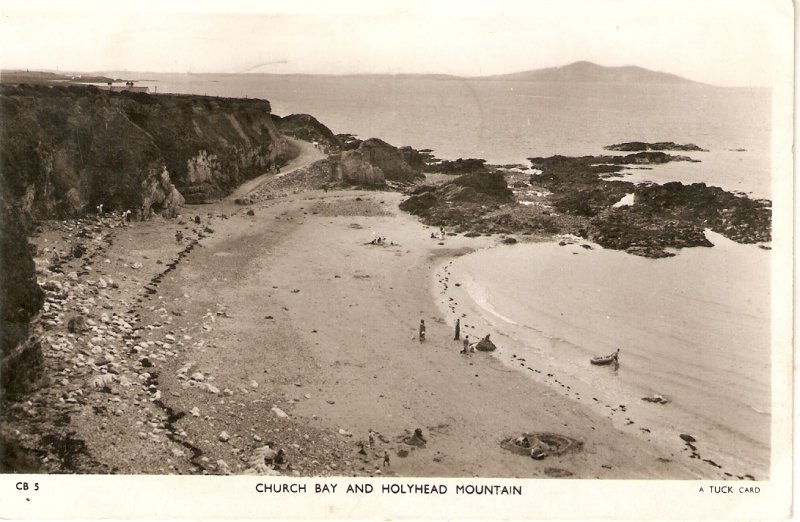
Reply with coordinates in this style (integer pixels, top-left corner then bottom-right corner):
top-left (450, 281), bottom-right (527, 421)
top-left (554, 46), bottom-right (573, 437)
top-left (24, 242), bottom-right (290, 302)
top-left (0, 86), bottom-right (288, 218)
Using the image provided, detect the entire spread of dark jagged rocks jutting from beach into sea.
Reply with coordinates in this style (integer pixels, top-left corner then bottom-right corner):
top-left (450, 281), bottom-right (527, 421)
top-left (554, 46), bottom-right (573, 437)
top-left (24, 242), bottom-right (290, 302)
top-left (401, 142), bottom-right (772, 258)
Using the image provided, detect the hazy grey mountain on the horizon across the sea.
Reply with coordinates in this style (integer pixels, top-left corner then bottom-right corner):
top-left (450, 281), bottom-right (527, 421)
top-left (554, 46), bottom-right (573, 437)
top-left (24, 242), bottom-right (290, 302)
top-left (481, 61), bottom-right (698, 83)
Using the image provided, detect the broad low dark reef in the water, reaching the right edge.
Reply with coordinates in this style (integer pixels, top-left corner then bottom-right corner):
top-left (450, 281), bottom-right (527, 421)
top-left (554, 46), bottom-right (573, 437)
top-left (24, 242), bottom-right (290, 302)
top-left (530, 150), bottom-right (772, 257)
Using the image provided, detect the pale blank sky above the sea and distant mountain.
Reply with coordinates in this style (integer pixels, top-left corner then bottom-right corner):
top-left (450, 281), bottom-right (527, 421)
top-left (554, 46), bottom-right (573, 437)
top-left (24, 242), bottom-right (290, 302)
top-left (0, 0), bottom-right (793, 86)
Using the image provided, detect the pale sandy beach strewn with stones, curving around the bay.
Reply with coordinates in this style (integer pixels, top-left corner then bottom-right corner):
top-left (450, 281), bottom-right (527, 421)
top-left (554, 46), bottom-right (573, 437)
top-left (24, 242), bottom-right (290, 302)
top-left (11, 139), bottom-right (744, 479)
